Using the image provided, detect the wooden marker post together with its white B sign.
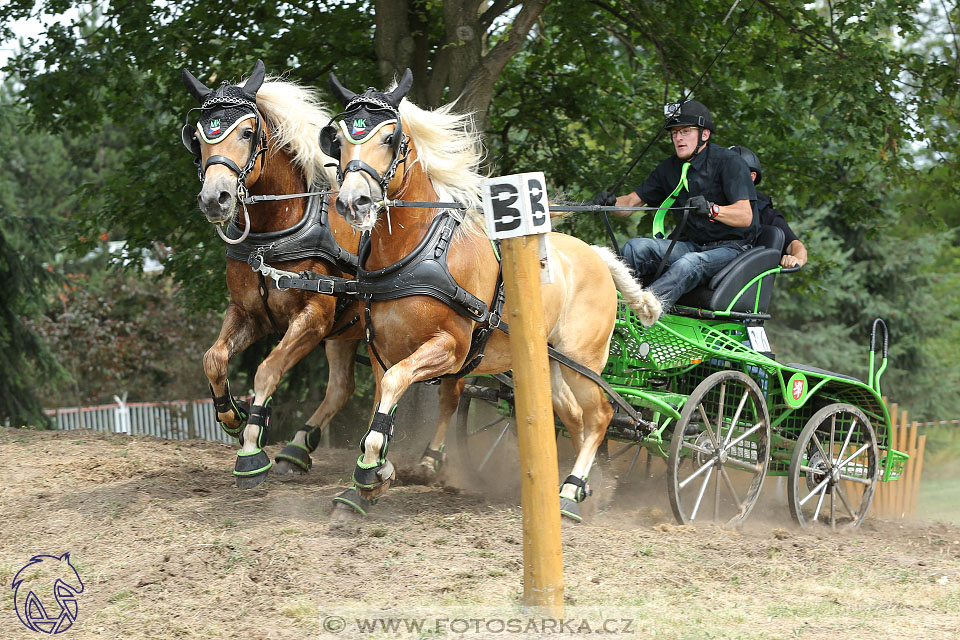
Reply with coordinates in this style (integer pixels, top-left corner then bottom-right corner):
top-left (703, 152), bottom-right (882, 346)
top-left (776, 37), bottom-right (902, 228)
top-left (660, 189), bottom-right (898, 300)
top-left (483, 172), bottom-right (563, 618)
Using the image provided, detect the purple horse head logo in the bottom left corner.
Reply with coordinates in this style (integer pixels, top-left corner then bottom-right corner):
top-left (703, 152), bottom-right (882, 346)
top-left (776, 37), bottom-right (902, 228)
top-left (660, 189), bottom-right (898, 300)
top-left (11, 553), bottom-right (83, 635)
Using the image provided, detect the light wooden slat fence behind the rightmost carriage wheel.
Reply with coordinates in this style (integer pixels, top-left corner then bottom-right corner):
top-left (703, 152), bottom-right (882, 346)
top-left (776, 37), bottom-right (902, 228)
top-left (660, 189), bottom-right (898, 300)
top-left (872, 398), bottom-right (927, 520)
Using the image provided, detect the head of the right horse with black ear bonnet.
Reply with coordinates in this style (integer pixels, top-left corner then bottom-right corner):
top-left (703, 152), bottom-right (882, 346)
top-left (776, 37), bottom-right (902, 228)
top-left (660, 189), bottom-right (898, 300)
top-left (320, 69), bottom-right (413, 231)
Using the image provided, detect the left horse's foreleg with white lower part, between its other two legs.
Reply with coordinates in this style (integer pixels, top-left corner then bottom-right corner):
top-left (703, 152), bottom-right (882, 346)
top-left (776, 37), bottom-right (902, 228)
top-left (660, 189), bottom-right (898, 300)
top-left (233, 312), bottom-right (324, 489)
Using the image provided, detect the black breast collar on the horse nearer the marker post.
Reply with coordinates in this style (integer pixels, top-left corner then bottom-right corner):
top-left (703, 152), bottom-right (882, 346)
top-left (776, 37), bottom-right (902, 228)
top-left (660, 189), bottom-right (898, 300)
top-left (357, 211), bottom-right (490, 322)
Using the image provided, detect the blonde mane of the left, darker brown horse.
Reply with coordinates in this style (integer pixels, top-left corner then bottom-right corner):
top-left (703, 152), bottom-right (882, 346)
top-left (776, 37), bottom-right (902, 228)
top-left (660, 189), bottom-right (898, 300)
top-left (257, 77), bottom-right (337, 188)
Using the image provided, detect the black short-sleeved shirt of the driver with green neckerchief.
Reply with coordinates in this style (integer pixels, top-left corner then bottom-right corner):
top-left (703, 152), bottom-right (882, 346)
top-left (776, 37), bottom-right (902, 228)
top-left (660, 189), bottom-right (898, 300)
top-left (636, 142), bottom-right (760, 244)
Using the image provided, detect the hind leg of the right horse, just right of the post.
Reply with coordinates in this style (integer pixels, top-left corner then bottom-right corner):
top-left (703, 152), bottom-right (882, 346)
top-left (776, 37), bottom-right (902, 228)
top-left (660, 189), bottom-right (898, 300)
top-left (551, 362), bottom-right (613, 522)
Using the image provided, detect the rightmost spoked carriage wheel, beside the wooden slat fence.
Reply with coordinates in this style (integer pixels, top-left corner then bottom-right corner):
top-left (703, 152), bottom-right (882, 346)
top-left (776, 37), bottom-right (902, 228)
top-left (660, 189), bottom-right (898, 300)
top-left (787, 403), bottom-right (879, 528)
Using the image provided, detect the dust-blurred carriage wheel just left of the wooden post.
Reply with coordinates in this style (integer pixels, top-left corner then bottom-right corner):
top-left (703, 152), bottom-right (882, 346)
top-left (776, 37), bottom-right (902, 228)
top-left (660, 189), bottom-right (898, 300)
top-left (457, 378), bottom-right (520, 490)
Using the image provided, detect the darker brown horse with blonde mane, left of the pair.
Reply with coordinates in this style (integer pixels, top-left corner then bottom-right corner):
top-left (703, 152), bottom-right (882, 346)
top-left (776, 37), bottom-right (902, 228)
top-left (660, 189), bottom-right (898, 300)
top-left (182, 61), bottom-right (360, 488)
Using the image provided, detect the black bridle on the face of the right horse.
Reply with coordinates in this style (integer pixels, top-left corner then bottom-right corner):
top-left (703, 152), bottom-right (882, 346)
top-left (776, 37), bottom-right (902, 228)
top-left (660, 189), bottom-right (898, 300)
top-left (319, 94), bottom-right (410, 198)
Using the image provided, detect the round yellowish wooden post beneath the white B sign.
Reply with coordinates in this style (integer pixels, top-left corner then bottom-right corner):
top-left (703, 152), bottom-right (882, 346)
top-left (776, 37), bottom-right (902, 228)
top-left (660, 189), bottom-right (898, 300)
top-left (501, 236), bottom-right (563, 618)
